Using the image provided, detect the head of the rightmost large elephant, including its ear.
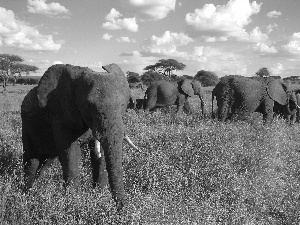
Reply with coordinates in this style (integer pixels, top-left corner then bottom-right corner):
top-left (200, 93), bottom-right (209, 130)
top-left (267, 79), bottom-right (299, 115)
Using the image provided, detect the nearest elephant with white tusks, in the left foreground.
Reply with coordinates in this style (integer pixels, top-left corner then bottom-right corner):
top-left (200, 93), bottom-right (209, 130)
top-left (21, 64), bottom-right (137, 210)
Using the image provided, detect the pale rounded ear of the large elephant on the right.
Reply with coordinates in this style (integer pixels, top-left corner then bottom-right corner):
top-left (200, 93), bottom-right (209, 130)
top-left (267, 80), bottom-right (288, 105)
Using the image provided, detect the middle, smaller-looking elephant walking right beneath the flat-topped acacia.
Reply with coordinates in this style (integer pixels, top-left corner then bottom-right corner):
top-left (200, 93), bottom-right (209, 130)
top-left (145, 79), bottom-right (205, 114)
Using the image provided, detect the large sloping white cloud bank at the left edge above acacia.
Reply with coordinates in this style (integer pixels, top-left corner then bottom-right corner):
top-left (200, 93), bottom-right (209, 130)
top-left (0, 7), bottom-right (61, 51)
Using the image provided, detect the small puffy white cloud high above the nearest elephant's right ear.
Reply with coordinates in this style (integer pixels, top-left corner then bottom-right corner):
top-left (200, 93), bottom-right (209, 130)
top-left (102, 8), bottom-right (138, 32)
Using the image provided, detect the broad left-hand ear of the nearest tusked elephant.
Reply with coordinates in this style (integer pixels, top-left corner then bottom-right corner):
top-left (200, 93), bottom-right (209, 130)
top-left (37, 64), bottom-right (65, 108)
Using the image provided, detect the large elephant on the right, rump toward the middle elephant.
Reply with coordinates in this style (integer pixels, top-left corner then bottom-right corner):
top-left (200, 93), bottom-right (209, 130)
top-left (212, 75), bottom-right (297, 123)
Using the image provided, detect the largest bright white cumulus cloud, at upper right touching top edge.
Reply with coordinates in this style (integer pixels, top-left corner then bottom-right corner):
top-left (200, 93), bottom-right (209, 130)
top-left (185, 0), bottom-right (262, 39)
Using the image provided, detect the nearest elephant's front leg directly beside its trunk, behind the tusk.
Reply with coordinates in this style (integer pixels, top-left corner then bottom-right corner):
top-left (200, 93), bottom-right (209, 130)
top-left (89, 139), bottom-right (108, 188)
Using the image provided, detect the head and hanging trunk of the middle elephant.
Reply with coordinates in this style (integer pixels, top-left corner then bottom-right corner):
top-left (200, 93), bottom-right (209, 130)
top-left (181, 79), bottom-right (206, 114)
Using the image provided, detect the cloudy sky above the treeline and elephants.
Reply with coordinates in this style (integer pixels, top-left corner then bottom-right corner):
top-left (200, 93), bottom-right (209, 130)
top-left (0, 0), bottom-right (300, 78)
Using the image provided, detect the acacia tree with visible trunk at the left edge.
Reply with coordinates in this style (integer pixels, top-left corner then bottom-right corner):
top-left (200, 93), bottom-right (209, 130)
top-left (0, 54), bottom-right (39, 91)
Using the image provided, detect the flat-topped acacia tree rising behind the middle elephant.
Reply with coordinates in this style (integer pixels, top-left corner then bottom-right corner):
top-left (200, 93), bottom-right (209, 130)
top-left (144, 59), bottom-right (185, 77)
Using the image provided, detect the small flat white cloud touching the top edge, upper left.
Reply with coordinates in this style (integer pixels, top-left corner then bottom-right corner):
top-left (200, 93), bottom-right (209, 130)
top-left (27, 0), bottom-right (69, 17)
